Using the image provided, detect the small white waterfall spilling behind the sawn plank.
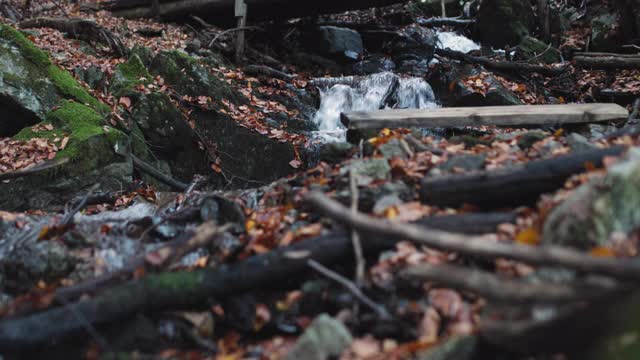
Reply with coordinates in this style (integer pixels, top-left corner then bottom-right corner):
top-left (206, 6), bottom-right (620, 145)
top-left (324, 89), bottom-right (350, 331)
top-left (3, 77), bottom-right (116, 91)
top-left (313, 72), bottom-right (437, 142)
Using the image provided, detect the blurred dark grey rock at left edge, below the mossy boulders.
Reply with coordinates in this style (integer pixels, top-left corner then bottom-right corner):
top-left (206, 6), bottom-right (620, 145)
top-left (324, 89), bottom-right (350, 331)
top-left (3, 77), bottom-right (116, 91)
top-left (2, 241), bottom-right (76, 288)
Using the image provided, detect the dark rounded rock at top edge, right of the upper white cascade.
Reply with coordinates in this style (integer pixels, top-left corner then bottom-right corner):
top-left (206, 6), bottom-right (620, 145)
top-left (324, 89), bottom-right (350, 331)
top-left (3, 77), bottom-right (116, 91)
top-left (475, 0), bottom-right (536, 48)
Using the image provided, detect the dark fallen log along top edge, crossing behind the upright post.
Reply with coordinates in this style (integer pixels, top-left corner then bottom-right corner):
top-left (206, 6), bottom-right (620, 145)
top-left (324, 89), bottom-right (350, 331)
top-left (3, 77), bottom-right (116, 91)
top-left (102, 0), bottom-right (403, 21)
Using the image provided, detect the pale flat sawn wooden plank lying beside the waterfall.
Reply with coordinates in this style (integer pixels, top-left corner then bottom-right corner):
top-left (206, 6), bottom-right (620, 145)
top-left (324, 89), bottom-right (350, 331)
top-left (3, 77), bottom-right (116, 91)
top-left (341, 103), bottom-right (629, 129)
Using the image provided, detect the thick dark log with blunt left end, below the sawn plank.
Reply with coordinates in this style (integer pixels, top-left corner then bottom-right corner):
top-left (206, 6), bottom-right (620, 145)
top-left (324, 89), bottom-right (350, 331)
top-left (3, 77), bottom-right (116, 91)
top-left (420, 146), bottom-right (626, 209)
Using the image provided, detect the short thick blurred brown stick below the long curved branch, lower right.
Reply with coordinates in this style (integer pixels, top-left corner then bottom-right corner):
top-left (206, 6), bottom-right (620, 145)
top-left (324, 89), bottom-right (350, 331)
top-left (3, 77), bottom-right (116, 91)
top-left (400, 264), bottom-right (617, 304)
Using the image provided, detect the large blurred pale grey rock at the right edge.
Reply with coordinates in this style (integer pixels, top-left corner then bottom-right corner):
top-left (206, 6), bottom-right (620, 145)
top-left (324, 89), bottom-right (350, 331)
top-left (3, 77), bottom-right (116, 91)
top-left (543, 148), bottom-right (640, 249)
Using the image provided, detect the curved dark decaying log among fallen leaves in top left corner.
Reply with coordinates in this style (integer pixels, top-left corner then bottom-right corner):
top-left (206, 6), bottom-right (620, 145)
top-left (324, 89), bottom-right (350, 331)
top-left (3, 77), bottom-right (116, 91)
top-left (18, 17), bottom-right (127, 57)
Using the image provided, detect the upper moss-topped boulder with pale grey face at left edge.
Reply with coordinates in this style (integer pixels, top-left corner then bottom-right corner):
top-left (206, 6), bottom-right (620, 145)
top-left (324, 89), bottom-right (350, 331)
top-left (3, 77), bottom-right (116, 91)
top-left (0, 25), bottom-right (109, 136)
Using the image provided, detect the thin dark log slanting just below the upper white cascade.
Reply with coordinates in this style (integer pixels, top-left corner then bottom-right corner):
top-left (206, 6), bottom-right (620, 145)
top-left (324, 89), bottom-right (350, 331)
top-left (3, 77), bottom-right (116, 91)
top-left (435, 49), bottom-right (568, 76)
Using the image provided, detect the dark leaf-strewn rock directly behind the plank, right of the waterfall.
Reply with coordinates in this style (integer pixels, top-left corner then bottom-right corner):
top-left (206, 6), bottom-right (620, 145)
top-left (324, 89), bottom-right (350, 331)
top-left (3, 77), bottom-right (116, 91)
top-left (429, 64), bottom-right (522, 107)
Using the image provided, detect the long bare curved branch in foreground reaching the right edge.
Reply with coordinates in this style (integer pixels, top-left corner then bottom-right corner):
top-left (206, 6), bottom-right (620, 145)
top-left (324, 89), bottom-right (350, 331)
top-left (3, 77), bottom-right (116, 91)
top-left (305, 192), bottom-right (640, 281)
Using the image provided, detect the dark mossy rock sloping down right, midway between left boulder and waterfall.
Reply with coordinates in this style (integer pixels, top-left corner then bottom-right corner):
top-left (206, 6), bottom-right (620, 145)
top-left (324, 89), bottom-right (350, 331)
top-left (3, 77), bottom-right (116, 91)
top-left (149, 51), bottom-right (240, 103)
